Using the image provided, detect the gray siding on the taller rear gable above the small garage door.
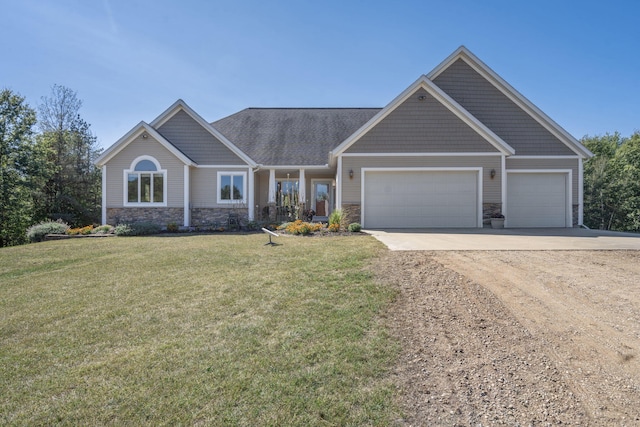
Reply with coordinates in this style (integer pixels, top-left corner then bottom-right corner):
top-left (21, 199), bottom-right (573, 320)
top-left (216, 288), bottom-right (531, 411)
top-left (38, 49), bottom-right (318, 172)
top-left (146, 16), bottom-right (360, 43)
top-left (434, 59), bottom-right (575, 156)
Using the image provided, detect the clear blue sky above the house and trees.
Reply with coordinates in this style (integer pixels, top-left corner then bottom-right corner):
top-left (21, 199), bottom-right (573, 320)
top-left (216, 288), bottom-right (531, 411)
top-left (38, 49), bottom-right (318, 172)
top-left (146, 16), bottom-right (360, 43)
top-left (0, 0), bottom-right (640, 147)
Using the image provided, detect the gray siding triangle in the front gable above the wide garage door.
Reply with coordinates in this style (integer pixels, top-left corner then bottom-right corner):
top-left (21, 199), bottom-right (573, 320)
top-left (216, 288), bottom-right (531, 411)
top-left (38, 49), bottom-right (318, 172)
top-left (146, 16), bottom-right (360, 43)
top-left (346, 89), bottom-right (497, 153)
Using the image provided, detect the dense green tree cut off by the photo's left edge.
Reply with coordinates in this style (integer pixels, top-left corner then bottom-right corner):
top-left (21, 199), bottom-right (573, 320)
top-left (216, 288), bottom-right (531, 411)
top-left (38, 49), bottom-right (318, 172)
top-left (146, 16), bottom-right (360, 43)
top-left (0, 89), bottom-right (42, 247)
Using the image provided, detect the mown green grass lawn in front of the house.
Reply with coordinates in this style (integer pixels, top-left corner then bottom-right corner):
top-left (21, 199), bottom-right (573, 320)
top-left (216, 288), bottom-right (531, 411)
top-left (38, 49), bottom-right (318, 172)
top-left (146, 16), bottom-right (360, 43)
top-left (0, 234), bottom-right (398, 426)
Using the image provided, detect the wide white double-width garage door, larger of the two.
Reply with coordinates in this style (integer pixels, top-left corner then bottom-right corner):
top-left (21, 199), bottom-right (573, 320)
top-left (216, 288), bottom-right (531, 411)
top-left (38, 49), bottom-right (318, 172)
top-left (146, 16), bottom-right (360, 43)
top-left (362, 170), bottom-right (479, 228)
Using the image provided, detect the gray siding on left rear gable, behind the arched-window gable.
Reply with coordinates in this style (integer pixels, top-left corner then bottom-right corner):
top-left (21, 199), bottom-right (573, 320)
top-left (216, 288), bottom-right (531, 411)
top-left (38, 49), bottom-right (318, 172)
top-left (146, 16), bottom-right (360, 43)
top-left (157, 111), bottom-right (245, 165)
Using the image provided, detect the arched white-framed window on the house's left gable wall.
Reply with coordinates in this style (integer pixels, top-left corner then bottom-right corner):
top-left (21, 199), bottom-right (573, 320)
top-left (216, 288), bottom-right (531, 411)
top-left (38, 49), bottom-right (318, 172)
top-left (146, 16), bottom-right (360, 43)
top-left (125, 156), bottom-right (167, 206)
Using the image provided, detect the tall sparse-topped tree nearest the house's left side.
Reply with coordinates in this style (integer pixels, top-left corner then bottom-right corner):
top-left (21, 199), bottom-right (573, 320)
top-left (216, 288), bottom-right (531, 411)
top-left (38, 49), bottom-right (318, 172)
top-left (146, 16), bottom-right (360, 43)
top-left (36, 85), bottom-right (101, 226)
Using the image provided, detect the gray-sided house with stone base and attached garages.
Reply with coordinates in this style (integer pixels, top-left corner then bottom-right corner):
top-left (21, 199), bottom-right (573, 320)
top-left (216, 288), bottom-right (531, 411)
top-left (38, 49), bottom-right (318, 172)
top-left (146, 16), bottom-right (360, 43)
top-left (96, 46), bottom-right (592, 228)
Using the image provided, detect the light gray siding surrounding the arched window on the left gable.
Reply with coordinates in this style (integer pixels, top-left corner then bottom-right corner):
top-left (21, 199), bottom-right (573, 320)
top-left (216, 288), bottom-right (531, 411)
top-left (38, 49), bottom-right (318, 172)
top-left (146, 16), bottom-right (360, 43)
top-left (107, 136), bottom-right (184, 208)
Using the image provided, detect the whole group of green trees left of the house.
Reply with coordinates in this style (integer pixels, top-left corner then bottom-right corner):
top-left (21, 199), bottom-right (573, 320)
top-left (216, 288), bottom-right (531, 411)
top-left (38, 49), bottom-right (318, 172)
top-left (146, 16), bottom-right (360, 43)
top-left (0, 85), bottom-right (101, 247)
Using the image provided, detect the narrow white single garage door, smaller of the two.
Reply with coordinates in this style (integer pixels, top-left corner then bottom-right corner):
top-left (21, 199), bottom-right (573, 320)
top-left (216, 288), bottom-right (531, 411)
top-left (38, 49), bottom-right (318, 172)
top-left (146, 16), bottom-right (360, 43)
top-left (506, 172), bottom-right (571, 227)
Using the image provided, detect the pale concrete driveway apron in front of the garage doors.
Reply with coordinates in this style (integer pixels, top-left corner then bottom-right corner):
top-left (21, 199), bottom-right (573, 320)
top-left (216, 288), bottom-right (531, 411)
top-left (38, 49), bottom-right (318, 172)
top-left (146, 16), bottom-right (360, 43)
top-left (365, 228), bottom-right (640, 251)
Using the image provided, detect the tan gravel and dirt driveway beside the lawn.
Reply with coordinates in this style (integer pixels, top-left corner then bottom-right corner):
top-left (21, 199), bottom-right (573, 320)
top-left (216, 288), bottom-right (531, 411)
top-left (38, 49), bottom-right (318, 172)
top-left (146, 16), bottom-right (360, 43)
top-left (376, 251), bottom-right (640, 426)
